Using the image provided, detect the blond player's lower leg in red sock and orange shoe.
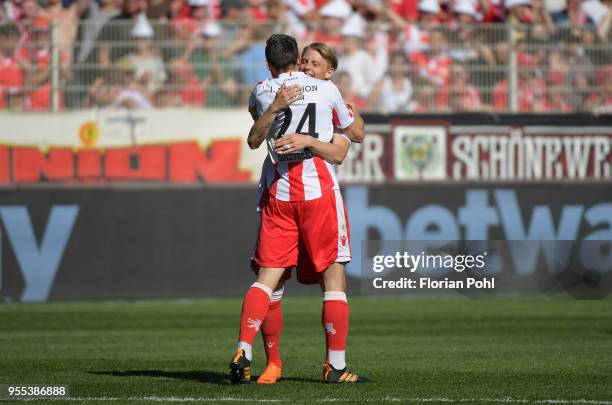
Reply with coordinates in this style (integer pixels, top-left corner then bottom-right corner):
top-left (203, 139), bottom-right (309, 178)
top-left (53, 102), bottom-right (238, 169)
top-left (257, 281), bottom-right (285, 384)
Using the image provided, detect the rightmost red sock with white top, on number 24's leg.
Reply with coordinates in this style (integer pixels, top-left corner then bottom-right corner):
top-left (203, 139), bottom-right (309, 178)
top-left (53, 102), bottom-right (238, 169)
top-left (322, 291), bottom-right (349, 370)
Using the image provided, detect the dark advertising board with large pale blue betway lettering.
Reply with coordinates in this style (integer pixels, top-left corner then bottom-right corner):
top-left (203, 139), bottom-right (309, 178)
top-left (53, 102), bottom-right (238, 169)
top-left (0, 183), bottom-right (612, 301)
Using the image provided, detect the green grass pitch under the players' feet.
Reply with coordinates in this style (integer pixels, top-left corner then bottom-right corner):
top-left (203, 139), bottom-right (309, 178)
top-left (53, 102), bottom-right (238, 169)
top-left (0, 297), bottom-right (612, 404)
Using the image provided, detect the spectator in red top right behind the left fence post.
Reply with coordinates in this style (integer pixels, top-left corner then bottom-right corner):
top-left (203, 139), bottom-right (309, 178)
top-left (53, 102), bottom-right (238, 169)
top-left (24, 16), bottom-right (73, 111)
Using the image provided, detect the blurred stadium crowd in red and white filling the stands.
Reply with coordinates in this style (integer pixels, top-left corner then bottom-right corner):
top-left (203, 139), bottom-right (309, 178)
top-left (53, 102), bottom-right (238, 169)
top-left (0, 0), bottom-right (612, 112)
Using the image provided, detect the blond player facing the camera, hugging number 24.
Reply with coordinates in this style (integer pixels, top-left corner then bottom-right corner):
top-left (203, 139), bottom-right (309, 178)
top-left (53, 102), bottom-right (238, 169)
top-left (253, 42), bottom-right (363, 384)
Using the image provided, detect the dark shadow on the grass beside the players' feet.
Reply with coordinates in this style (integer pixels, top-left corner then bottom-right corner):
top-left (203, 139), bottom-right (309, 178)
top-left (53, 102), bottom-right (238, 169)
top-left (88, 370), bottom-right (320, 385)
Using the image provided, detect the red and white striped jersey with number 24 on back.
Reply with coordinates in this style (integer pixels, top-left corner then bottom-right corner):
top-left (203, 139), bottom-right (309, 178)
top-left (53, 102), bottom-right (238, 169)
top-left (249, 72), bottom-right (354, 205)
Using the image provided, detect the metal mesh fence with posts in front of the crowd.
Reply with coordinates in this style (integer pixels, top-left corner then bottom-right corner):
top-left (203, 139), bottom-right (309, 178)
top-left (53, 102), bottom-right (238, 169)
top-left (0, 20), bottom-right (612, 113)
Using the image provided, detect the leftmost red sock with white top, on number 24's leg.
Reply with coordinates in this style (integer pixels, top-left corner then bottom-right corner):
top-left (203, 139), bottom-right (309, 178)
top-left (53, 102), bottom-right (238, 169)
top-left (239, 283), bottom-right (272, 352)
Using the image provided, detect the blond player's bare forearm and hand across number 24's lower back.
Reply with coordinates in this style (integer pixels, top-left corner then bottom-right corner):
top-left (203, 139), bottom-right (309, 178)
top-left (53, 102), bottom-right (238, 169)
top-left (274, 134), bottom-right (351, 165)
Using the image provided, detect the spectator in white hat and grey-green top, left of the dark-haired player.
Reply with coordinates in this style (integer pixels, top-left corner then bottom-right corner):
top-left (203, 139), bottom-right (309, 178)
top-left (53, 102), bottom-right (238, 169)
top-left (182, 23), bottom-right (240, 107)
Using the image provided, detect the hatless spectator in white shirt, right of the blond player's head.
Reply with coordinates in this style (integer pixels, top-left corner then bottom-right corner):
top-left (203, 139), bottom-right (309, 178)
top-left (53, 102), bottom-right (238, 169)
top-left (369, 52), bottom-right (413, 112)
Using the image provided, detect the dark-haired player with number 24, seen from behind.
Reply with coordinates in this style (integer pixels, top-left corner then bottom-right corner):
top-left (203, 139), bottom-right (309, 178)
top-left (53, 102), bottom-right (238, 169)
top-left (230, 34), bottom-right (363, 383)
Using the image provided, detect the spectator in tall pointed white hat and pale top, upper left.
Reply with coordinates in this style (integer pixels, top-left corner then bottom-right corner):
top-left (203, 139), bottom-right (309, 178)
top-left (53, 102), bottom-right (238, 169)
top-left (126, 14), bottom-right (167, 97)
